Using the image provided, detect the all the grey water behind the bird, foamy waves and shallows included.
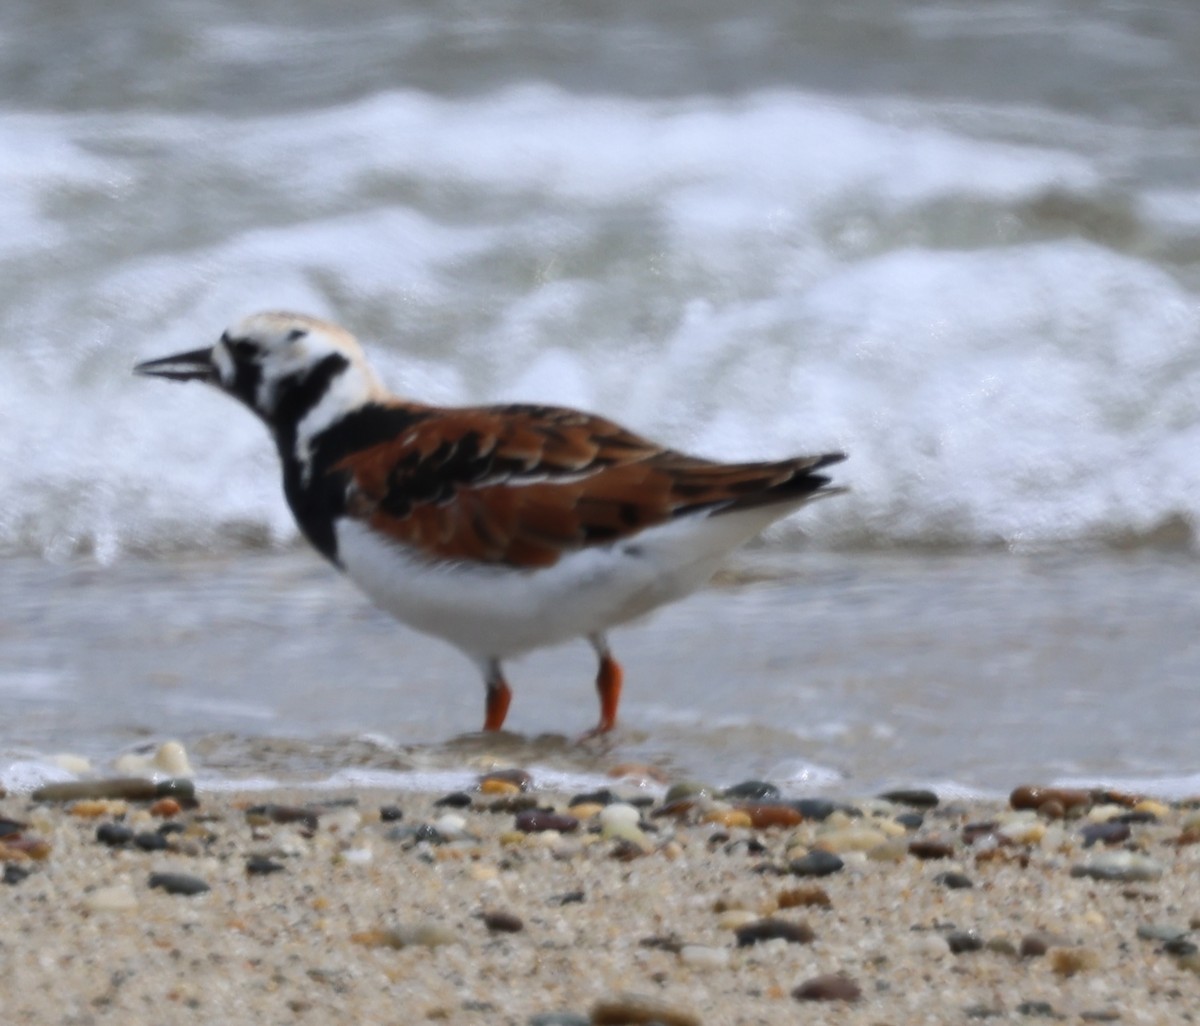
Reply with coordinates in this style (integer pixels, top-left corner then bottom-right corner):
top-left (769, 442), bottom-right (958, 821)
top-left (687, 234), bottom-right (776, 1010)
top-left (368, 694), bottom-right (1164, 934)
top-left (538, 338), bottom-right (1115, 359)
top-left (0, 0), bottom-right (1200, 792)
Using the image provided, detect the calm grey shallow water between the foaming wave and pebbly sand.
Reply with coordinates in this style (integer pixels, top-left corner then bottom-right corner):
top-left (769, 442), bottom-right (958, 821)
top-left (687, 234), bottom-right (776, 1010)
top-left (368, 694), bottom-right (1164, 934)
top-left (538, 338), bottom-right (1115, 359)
top-left (0, 551), bottom-right (1200, 792)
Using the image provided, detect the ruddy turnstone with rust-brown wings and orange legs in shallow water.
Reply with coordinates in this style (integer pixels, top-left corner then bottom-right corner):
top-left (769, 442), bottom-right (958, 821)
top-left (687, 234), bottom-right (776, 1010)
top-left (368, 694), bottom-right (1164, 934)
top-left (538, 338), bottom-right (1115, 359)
top-left (134, 313), bottom-right (845, 733)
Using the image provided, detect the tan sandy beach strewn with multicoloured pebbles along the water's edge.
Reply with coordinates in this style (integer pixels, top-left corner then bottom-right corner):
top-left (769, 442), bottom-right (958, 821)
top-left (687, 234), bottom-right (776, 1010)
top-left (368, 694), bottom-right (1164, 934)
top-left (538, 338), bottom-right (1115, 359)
top-left (0, 767), bottom-right (1200, 1026)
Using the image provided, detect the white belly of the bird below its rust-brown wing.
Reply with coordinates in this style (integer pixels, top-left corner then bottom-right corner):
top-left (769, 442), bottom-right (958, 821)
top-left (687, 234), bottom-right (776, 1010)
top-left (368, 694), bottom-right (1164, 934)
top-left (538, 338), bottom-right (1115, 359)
top-left (336, 506), bottom-right (788, 661)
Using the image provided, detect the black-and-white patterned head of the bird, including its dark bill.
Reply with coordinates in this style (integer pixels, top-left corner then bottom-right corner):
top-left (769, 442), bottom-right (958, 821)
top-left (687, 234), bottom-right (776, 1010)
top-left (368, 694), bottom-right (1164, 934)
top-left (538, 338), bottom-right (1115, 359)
top-left (133, 313), bottom-right (384, 428)
